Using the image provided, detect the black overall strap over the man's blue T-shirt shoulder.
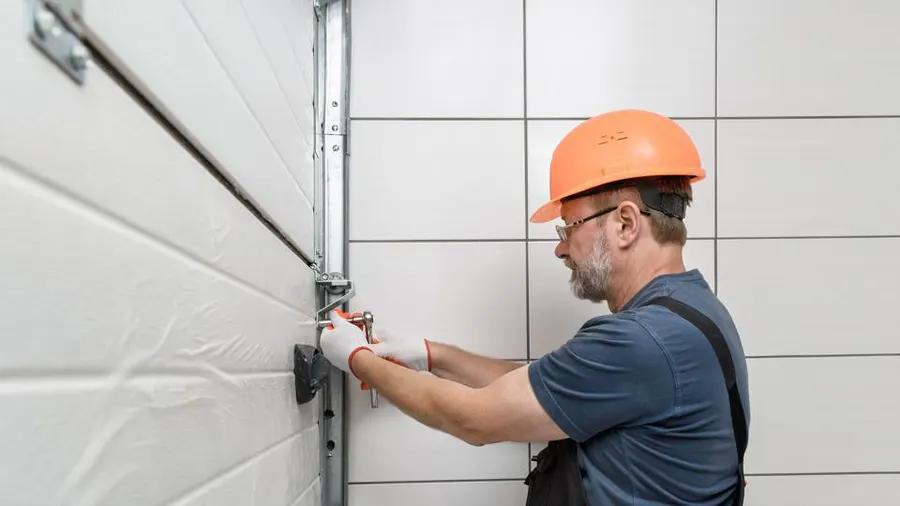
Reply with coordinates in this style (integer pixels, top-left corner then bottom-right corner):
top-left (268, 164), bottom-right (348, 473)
top-left (647, 297), bottom-right (747, 504)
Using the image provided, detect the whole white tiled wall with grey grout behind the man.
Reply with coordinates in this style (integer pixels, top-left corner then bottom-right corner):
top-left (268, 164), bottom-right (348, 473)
top-left (350, 0), bottom-right (900, 506)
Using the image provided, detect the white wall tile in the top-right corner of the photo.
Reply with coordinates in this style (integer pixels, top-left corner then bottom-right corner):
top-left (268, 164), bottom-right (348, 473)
top-left (717, 0), bottom-right (900, 117)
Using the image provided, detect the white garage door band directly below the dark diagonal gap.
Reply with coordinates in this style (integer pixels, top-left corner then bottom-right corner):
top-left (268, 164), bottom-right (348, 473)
top-left (0, 2), bottom-right (315, 314)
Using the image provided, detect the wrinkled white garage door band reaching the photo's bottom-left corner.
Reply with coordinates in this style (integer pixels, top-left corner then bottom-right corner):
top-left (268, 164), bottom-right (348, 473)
top-left (0, 374), bottom-right (317, 506)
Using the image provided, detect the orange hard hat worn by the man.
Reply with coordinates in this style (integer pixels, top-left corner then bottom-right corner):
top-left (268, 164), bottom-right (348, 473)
top-left (531, 110), bottom-right (706, 223)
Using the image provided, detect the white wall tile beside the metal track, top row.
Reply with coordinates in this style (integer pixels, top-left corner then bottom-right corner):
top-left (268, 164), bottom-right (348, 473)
top-left (350, 0), bottom-right (524, 118)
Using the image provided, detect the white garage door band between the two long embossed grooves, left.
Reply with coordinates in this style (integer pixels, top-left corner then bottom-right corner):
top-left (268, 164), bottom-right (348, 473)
top-left (0, 160), bottom-right (316, 374)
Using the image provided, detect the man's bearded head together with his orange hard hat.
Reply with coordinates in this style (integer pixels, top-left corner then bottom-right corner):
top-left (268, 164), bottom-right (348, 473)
top-left (531, 110), bottom-right (705, 301)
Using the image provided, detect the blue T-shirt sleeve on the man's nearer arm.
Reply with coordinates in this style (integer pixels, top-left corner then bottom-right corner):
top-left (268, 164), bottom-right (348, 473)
top-left (528, 317), bottom-right (675, 442)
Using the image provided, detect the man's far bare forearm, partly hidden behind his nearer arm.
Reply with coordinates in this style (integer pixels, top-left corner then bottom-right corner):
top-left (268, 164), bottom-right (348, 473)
top-left (428, 341), bottom-right (523, 388)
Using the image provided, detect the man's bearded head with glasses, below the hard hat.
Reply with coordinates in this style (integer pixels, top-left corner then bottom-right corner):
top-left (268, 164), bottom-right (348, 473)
top-left (555, 176), bottom-right (692, 302)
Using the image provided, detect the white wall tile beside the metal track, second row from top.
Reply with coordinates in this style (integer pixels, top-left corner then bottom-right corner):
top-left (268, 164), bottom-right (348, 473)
top-left (349, 120), bottom-right (525, 241)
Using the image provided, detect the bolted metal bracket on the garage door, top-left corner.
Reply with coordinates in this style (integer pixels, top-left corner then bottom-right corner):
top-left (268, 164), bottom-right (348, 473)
top-left (25, 0), bottom-right (91, 84)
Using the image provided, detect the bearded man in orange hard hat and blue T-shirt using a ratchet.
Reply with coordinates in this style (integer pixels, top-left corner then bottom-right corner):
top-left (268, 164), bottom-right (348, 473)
top-left (321, 110), bottom-right (749, 505)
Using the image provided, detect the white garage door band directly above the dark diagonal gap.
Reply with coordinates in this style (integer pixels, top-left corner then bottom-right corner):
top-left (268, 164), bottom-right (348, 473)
top-left (84, 0), bottom-right (315, 258)
